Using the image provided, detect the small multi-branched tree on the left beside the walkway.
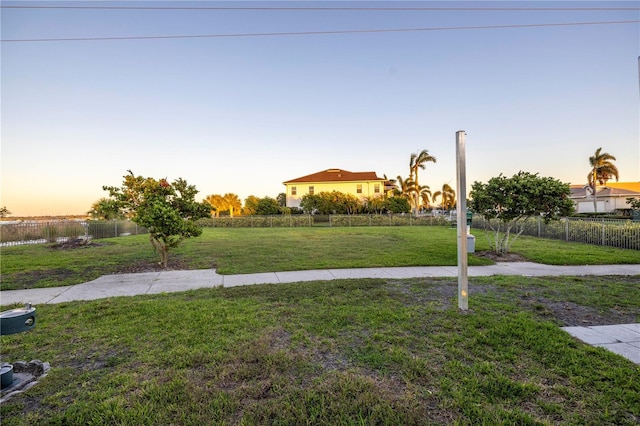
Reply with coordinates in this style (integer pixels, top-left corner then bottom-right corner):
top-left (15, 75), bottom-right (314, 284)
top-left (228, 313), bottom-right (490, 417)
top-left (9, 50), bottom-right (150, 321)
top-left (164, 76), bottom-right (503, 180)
top-left (102, 170), bottom-right (211, 268)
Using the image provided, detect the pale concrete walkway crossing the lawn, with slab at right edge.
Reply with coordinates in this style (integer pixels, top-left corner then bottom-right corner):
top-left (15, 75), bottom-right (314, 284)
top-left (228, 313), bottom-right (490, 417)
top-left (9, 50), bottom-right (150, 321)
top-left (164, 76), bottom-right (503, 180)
top-left (0, 262), bottom-right (640, 364)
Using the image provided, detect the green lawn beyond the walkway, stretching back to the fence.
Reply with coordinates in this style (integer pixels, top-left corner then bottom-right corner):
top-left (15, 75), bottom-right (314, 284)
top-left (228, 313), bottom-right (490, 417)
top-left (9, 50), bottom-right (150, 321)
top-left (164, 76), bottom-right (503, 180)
top-left (0, 226), bottom-right (640, 290)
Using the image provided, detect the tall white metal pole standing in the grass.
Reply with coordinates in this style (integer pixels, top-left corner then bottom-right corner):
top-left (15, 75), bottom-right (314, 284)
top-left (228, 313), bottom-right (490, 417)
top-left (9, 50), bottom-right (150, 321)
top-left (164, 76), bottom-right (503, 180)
top-left (456, 130), bottom-right (469, 311)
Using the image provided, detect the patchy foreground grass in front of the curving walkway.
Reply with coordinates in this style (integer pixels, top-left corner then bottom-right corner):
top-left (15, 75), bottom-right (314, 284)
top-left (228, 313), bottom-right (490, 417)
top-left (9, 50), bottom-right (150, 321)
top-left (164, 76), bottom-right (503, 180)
top-left (0, 277), bottom-right (640, 426)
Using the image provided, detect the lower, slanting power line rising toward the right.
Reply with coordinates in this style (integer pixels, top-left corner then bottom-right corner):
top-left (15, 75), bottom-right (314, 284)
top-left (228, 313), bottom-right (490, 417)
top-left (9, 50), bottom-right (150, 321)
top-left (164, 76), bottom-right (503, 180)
top-left (0, 20), bottom-right (640, 43)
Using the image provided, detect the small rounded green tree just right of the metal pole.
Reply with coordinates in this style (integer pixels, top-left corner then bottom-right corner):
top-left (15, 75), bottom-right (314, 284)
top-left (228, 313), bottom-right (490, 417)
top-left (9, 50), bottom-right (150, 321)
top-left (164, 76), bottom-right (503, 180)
top-left (469, 171), bottom-right (574, 255)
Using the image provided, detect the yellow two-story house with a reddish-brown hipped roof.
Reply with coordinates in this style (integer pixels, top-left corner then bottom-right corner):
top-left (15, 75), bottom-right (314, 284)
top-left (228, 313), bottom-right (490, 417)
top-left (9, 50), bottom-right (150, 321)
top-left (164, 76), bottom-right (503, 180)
top-left (283, 169), bottom-right (386, 207)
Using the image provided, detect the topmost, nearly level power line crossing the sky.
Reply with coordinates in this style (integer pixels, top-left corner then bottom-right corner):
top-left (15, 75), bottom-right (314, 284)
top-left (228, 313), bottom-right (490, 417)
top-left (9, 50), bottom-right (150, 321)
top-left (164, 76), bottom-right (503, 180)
top-left (0, 5), bottom-right (640, 11)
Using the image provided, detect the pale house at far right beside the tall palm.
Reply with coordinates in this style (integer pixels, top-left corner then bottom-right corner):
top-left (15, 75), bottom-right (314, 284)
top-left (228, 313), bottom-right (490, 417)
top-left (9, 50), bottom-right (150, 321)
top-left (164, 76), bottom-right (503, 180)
top-left (570, 182), bottom-right (640, 213)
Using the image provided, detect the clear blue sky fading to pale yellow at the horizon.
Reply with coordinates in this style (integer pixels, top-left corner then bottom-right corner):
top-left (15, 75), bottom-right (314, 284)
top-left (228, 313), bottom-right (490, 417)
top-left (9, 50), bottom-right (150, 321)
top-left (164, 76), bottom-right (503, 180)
top-left (0, 1), bottom-right (640, 216)
